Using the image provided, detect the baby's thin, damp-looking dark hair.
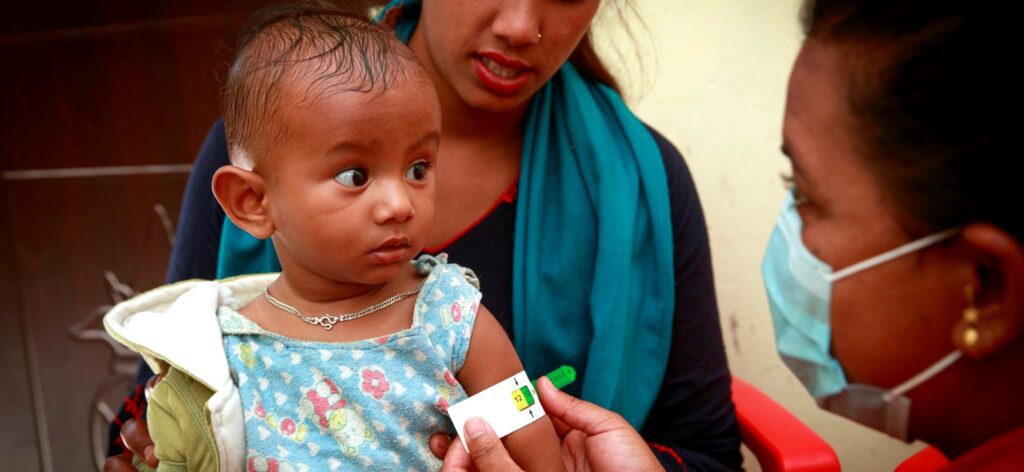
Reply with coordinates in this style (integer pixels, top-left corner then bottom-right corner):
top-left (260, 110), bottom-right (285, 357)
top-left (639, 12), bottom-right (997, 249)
top-left (223, 3), bottom-right (422, 170)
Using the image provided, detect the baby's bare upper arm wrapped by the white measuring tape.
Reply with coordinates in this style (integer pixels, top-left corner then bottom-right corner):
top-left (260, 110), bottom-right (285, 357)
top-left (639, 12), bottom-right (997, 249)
top-left (452, 305), bottom-right (565, 471)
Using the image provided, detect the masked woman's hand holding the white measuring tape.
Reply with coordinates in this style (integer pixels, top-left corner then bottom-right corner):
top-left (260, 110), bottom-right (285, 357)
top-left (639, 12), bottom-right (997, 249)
top-left (430, 378), bottom-right (663, 472)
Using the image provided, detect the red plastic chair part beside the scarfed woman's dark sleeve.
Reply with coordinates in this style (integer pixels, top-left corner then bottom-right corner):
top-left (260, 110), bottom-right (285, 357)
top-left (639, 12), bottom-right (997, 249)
top-left (732, 377), bottom-right (840, 472)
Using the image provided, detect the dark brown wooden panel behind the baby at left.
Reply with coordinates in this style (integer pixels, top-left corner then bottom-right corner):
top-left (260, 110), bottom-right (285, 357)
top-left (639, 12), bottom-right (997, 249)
top-left (0, 0), bottom-right (268, 471)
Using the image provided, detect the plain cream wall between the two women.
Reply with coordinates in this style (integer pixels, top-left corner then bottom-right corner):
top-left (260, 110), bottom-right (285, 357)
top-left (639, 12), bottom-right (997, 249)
top-left (595, 0), bottom-right (921, 471)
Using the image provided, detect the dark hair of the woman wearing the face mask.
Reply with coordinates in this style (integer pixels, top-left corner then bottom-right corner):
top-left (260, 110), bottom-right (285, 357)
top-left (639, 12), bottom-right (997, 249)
top-left (803, 0), bottom-right (1024, 241)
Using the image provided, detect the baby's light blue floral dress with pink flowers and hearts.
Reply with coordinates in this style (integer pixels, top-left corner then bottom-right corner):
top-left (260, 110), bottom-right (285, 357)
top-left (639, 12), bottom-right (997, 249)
top-left (217, 259), bottom-right (480, 472)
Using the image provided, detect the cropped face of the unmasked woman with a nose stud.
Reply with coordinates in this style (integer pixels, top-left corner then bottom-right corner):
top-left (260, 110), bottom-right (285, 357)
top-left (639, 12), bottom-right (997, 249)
top-left (410, 0), bottom-right (599, 113)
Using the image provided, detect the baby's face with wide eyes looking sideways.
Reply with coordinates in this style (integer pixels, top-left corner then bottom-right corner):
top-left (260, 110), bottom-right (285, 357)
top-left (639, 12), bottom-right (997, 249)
top-left (260, 75), bottom-right (441, 284)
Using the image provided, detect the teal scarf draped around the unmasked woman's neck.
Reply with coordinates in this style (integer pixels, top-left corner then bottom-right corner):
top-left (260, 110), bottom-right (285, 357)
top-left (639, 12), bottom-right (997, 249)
top-left (217, 0), bottom-right (675, 428)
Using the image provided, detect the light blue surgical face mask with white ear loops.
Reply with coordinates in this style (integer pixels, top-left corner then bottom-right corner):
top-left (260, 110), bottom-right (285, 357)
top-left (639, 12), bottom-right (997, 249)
top-left (762, 195), bottom-right (961, 441)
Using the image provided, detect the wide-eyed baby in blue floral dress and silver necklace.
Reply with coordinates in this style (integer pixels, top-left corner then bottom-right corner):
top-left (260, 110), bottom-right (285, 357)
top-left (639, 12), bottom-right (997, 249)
top-left (104, 6), bottom-right (562, 471)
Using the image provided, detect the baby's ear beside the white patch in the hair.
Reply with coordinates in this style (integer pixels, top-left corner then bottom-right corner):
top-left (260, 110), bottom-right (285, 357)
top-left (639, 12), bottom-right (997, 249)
top-left (213, 166), bottom-right (274, 240)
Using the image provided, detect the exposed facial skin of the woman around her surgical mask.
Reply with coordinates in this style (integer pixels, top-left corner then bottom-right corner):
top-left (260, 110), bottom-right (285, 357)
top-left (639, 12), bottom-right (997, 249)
top-left (783, 39), bottom-right (970, 396)
